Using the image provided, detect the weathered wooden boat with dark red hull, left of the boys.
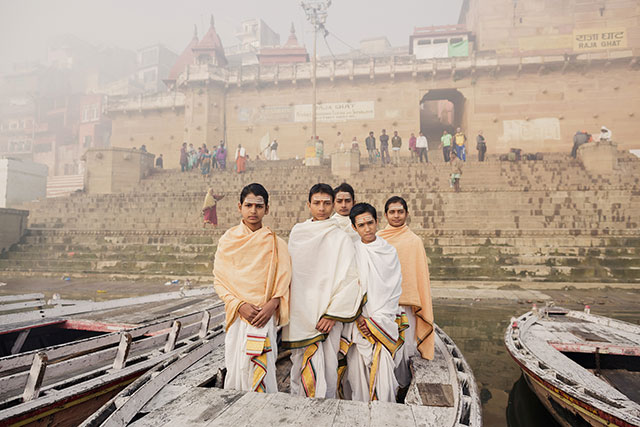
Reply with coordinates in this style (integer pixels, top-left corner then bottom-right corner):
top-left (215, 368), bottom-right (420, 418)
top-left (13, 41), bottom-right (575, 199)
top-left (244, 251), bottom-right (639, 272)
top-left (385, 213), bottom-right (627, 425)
top-left (0, 288), bottom-right (224, 426)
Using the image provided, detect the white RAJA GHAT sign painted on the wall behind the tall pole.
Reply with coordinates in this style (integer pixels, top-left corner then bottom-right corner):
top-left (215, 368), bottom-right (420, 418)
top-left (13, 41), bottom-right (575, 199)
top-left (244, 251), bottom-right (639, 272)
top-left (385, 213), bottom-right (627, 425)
top-left (293, 101), bottom-right (375, 122)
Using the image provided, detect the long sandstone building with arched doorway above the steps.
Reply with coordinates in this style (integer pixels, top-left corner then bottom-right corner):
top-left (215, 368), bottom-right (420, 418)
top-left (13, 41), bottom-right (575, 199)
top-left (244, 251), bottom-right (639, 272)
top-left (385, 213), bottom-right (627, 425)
top-left (109, 0), bottom-right (640, 167)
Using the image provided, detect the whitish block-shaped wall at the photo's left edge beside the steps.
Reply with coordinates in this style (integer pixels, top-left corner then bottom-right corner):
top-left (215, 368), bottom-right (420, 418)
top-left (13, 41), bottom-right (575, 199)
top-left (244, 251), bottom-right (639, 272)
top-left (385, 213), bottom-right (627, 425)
top-left (0, 159), bottom-right (48, 208)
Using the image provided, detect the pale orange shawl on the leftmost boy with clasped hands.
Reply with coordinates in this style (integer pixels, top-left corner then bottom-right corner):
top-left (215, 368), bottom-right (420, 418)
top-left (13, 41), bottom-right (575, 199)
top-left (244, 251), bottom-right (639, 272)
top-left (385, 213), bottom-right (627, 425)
top-left (213, 223), bottom-right (291, 329)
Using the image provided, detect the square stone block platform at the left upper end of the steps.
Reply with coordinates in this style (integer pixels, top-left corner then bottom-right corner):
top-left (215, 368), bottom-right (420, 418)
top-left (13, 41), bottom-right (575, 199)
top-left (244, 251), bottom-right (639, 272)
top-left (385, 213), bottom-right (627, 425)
top-left (85, 147), bottom-right (155, 194)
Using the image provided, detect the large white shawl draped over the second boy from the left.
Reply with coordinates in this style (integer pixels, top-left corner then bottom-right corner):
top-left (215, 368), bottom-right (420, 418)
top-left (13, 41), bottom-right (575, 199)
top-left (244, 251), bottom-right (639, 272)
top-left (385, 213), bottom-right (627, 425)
top-left (282, 218), bottom-right (363, 348)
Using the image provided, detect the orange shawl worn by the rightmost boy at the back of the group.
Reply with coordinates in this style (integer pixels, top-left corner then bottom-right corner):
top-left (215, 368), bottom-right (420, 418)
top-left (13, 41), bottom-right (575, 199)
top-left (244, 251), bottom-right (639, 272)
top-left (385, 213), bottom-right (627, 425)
top-left (378, 224), bottom-right (435, 360)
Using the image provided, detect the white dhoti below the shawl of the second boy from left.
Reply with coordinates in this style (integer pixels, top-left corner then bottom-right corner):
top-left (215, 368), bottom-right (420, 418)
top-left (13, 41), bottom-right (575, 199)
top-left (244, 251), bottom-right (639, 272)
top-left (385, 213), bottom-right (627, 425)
top-left (290, 322), bottom-right (344, 399)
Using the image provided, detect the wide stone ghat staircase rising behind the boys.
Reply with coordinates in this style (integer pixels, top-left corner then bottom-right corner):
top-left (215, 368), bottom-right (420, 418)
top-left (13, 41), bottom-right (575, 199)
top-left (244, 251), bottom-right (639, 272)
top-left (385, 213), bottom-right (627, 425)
top-left (5, 155), bottom-right (640, 282)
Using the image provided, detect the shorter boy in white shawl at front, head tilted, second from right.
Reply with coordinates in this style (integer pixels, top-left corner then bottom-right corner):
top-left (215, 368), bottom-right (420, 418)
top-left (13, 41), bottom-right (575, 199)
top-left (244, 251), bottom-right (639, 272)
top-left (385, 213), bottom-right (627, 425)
top-left (343, 203), bottom-right (408, 402)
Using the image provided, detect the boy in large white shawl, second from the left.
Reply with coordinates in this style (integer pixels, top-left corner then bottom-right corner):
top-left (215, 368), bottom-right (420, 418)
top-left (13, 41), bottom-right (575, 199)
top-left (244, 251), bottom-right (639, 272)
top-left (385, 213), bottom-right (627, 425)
top-left (282, 184), bottom-right (365, 398)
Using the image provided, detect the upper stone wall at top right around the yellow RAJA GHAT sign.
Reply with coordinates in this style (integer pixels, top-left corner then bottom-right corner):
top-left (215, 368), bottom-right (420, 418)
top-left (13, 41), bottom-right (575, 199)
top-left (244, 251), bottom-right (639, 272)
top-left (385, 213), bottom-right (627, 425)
top-left (460, 0), bottom-right (640, 55)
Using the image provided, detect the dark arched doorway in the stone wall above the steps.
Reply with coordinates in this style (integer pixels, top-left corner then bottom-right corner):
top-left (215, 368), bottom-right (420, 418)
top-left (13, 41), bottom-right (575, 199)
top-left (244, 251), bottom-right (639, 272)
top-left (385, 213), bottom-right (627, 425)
top-left (420, 89), bottom-right (465, 152)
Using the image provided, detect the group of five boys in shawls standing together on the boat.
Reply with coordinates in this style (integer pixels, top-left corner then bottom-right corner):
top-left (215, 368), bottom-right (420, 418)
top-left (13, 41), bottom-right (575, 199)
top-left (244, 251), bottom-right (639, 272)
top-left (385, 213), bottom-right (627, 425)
top-left (213, 183), bottom-right (434, 402)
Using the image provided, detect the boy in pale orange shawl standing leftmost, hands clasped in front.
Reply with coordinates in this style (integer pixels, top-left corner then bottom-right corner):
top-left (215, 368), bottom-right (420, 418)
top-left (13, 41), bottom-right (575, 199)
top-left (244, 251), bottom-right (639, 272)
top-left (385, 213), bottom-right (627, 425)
top-left (213, 183), bottom-right (291, 393)
